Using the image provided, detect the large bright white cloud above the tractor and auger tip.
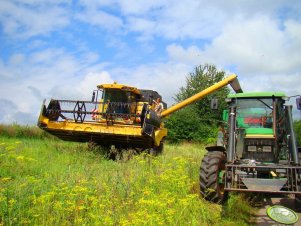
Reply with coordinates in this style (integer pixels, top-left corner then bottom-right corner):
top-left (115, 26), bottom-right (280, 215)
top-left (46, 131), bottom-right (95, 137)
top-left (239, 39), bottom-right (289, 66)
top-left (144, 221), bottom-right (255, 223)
top-left (167, 16), bottom-right (301, 95)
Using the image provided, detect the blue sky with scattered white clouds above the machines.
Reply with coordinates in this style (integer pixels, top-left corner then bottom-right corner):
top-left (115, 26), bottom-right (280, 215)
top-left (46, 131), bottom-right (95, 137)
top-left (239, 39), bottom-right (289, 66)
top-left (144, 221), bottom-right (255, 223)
top-left (0, 0), bottom-right (301, 125)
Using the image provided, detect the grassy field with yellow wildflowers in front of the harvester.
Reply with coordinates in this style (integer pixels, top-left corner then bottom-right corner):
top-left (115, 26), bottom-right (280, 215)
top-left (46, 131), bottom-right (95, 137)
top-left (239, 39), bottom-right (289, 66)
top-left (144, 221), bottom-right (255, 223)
top-left (0, 132), bottom-right (252, 225)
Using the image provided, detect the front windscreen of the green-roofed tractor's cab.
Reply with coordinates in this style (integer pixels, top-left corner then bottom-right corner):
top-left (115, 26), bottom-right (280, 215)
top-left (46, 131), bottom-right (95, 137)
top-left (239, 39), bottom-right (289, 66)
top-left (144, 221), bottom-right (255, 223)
top-left (237, 98), bottom-right (273, 128)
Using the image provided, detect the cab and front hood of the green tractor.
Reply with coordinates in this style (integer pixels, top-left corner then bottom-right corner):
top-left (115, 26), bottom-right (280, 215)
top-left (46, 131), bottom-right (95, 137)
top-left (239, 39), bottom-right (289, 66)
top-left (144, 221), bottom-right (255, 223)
top-left (224, 93), bottom-right (288, 163)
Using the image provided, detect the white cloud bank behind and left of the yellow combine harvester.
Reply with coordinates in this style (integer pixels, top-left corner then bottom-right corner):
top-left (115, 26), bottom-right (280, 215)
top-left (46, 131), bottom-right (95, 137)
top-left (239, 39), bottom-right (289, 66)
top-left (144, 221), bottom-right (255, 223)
top-left (0, 49), bottom-right (113, 123)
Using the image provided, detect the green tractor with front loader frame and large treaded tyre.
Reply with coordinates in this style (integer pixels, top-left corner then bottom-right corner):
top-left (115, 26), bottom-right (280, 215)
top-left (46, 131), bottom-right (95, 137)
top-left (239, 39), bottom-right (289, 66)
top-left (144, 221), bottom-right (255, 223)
top-left (200, 92), bottom-right (301, 206)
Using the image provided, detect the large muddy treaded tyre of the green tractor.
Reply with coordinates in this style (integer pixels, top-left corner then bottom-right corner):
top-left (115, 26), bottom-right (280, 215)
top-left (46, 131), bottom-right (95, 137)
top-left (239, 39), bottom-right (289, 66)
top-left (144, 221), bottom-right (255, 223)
top-left (200, 151), bottom-right (226, 203)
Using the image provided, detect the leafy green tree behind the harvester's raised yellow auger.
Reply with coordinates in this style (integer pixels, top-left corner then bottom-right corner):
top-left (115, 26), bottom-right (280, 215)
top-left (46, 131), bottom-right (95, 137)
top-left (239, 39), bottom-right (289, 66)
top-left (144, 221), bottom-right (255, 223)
top-left (166, 64), bottom-right (230, 142)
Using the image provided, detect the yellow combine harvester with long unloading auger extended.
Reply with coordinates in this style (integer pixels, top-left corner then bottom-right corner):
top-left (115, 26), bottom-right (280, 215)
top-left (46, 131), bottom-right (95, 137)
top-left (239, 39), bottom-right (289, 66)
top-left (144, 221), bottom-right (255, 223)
top-left (38, 75), bottom-right (242, 153)
